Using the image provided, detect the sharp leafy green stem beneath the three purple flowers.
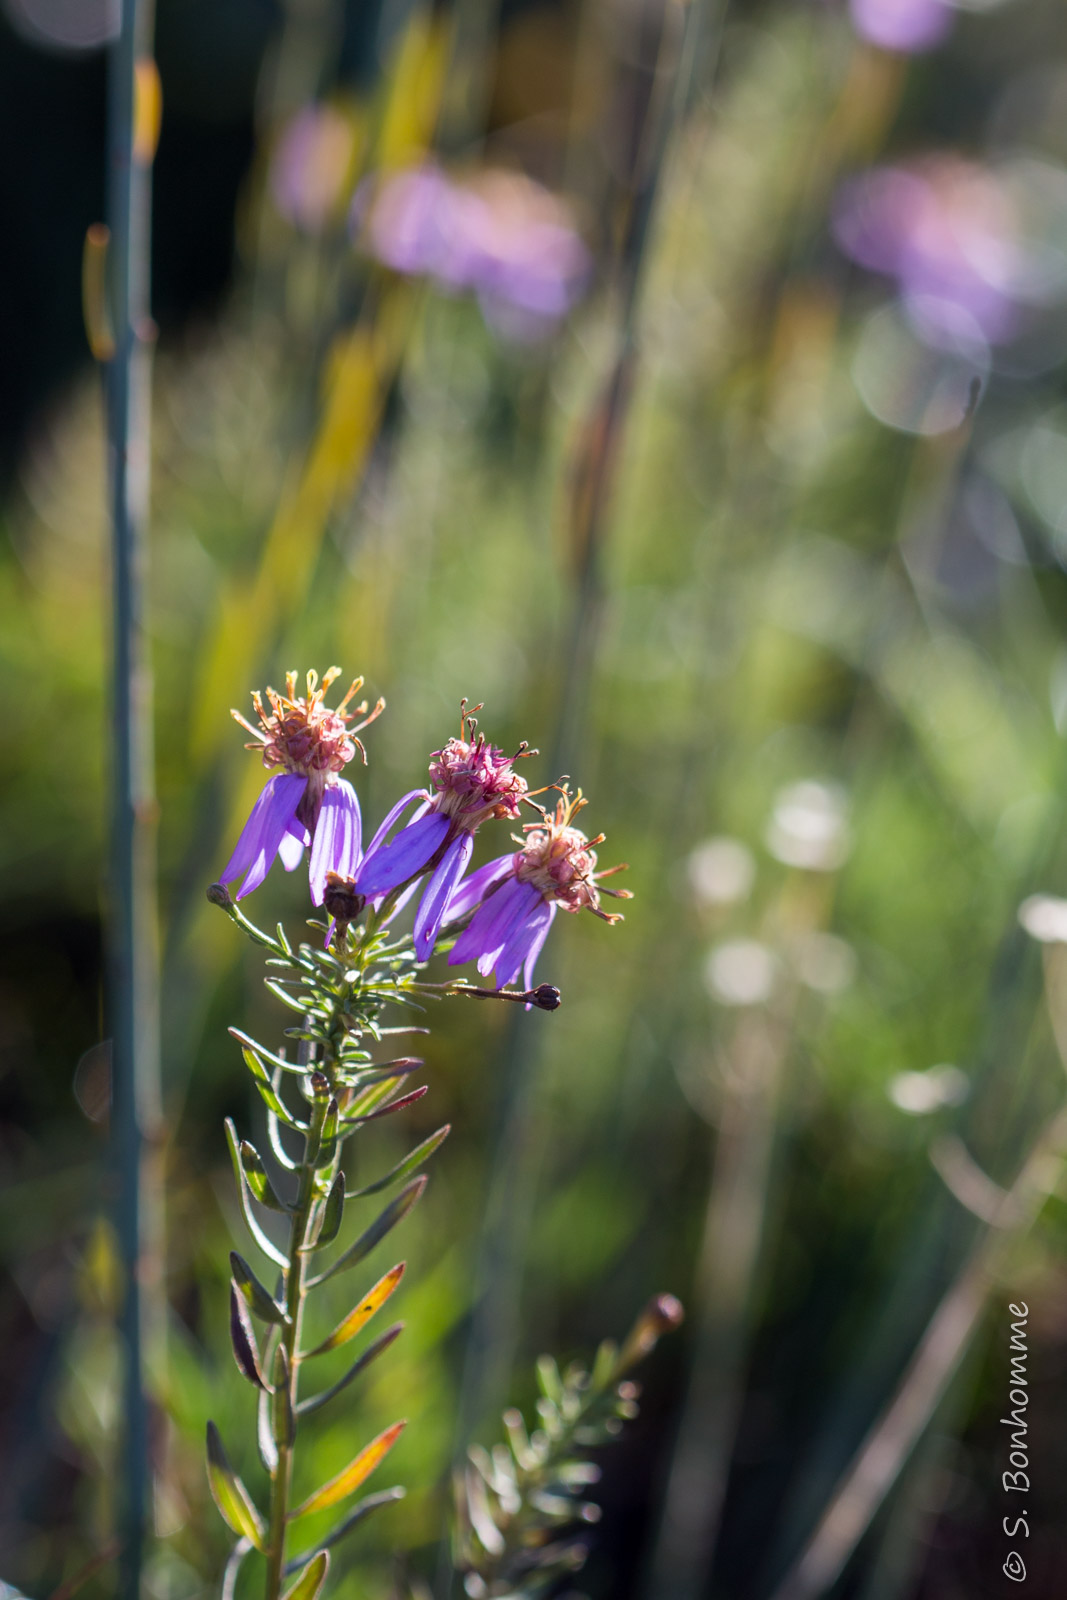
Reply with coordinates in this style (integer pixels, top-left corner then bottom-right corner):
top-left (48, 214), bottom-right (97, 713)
top-left (208, 886), bottom-right (450, 1600)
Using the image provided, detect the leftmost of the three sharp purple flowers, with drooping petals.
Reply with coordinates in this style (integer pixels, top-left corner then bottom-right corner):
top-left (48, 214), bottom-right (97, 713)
top-left (219, 667), bottom-right (386, 906)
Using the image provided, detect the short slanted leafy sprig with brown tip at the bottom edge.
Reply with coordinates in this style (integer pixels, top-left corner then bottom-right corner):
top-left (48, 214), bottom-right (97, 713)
top-left (454, 1294), bottom-right (681, 1600)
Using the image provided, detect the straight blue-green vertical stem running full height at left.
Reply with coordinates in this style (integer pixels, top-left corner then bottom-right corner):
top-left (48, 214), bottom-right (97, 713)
top-left (106, 0), bottom-right (160, 1600)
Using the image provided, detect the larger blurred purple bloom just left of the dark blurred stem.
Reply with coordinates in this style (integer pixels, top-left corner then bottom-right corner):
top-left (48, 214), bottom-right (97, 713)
top-left (352, 163), bottom-right (590, 339)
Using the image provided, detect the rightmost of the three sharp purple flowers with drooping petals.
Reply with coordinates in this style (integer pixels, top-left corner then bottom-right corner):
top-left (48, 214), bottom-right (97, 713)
top-left (445, 789), bottom-right (630, 989)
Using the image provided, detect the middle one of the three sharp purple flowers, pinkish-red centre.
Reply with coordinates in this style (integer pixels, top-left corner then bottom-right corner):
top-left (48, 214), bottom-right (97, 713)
top-left (355, 702), bottom-right (528, 962)
